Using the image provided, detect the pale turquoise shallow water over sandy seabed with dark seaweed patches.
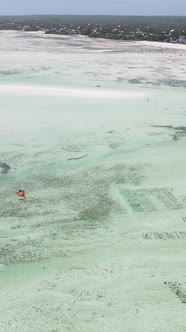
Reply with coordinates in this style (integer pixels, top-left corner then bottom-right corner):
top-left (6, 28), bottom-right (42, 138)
top-left (0, 32), bottom-right (186, 332)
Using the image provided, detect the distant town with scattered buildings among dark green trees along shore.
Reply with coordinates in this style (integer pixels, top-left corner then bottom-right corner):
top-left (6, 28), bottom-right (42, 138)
top-left (0, 15), bottom-right (186, 44)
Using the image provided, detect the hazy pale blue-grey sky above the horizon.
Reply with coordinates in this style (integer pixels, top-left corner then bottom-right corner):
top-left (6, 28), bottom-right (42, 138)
top-left (0, 0), bottom-right (186, 16)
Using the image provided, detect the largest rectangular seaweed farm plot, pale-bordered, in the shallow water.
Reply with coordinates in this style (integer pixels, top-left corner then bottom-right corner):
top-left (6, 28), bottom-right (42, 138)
top-left (118, 187), bottom-right (183, 213)
